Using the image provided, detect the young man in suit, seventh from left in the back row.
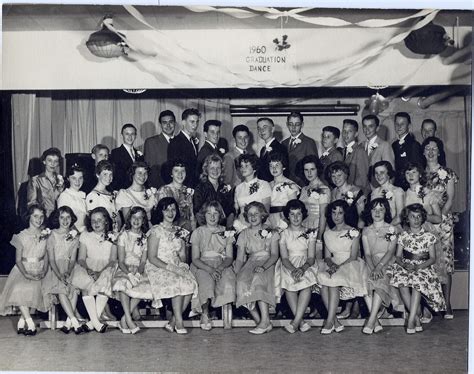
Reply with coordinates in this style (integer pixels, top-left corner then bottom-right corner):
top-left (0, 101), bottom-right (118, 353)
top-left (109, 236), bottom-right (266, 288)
top-left (282, 112), bottom-right (318, 186)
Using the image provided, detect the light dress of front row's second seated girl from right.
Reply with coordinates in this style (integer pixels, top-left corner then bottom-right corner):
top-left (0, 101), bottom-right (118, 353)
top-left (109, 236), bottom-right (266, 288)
top-left (362, 223), bottom-right (405, 312)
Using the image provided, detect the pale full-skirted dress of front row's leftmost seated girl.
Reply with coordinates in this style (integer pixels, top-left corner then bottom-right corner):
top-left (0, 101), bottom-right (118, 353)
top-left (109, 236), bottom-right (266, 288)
top-left (0, 230), bottom-right (50, 315)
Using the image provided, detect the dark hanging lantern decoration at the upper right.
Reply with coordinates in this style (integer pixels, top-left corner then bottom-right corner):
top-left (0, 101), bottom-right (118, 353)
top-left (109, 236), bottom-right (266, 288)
top-left (405, 22), bottom-right (454, 55)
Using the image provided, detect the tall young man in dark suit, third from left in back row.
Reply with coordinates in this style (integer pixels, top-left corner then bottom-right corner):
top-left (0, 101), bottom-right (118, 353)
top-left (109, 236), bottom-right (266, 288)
top-left (168, 108), bottom-right (201, 188)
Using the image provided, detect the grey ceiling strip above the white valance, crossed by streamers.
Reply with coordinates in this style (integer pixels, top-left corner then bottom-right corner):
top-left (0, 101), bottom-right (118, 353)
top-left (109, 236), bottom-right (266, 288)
top-left (3, 4), bottom-right (472, 31)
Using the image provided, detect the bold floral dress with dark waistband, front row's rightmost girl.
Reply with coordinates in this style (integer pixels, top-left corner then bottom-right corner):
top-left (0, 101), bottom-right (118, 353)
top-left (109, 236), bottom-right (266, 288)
top-left (387, 229), bottom-right (446, 312)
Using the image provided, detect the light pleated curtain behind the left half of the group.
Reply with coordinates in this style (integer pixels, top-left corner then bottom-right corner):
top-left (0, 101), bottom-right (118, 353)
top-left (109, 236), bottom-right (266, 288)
top-left (12, 92), bottom-right (232, 197)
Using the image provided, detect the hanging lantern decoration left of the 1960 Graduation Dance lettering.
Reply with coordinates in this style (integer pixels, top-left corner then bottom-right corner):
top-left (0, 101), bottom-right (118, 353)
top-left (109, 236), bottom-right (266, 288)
top-left (86, 16), bottom-right (128, 58)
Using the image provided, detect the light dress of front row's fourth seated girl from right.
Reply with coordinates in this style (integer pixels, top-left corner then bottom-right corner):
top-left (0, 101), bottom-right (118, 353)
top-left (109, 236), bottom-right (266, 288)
top-left (276, 229), bottom-right (318, 291)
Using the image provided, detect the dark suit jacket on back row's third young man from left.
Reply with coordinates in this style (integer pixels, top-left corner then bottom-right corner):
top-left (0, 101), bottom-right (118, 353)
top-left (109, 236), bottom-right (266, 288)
top-left (168, 131), bottom-right (199, 188)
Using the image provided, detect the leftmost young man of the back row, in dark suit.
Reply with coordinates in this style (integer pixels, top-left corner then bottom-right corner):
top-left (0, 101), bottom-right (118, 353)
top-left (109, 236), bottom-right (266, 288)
top-left (110, 123), bottom-right (145, 191)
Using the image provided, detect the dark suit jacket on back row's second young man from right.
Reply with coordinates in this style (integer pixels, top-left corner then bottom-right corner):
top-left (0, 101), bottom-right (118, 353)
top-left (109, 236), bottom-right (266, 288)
top-left (392, 134), bottom-right (423, 187)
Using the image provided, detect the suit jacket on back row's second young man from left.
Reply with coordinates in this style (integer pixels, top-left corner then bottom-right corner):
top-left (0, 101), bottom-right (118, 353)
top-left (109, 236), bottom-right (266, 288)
top-left (144, 133), bottom-right (169, 188)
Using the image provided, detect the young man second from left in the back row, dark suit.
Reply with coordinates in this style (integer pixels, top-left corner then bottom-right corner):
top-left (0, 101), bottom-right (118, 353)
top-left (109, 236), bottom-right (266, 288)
top-left (144, 110), bottom-right (176, 188)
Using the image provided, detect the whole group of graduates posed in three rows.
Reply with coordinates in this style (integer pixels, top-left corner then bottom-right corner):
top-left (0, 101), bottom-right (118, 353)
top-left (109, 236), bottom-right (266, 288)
top-left (0, 109), bottom-right (457, 335)
